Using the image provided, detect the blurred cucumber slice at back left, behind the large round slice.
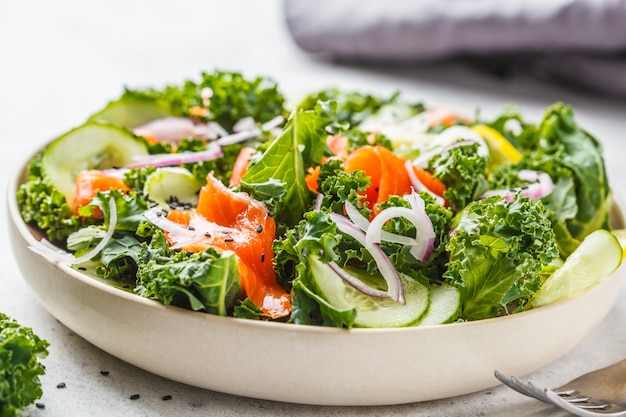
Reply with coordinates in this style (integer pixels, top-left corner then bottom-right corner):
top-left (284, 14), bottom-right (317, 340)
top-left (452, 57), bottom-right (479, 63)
top-left (88, 92), bottom-right (172, 129)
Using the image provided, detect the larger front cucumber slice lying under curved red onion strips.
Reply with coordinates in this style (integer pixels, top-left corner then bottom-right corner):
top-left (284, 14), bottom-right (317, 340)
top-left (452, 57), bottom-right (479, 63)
top-left (308, 256), bottom-right (430, 327)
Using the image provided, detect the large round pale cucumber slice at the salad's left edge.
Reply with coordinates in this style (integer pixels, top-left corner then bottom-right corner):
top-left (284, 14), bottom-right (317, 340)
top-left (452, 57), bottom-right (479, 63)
top-left (42, 123), bottom-right (148, 202)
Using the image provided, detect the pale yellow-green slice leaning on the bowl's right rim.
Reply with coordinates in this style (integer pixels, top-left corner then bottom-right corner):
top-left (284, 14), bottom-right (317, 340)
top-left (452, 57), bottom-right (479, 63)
top-left (530, 229), bottom-right (624, 307)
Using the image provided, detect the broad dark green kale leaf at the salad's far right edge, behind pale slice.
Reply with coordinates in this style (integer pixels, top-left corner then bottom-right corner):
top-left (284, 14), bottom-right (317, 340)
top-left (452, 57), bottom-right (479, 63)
top-left (486, 103), bottom-right (612, 257)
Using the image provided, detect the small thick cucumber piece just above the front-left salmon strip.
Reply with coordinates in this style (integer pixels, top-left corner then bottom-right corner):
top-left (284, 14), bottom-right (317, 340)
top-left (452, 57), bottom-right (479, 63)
top-left (143, 167), bottom-right (203, 208)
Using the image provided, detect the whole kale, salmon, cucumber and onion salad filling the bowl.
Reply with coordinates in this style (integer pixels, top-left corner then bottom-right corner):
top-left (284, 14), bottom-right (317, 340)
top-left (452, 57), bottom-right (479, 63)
top-left (17, 71), bottom-right (622, 328)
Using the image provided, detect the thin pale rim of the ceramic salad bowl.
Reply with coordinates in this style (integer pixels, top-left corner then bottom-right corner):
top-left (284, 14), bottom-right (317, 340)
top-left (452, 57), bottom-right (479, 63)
top-left (7, 145), bottom-right (626, 335)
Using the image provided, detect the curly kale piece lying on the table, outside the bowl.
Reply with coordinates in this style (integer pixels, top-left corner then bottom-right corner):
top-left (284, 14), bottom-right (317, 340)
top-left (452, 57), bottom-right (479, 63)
top-left (0, 313), bottom-right (49, 417)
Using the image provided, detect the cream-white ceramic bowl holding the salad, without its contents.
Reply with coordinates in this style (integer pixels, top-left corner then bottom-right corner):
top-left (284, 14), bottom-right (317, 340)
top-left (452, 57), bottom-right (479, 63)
top-left (8, 151), bottom-right (624, 405)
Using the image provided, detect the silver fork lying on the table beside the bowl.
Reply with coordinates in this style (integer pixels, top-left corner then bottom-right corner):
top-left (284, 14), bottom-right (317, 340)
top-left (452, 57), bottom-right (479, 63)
top-left (494, 359), bottom-right (626, 417)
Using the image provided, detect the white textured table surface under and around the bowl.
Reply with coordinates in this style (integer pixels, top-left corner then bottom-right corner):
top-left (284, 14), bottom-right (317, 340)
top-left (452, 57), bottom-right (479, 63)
top-left (0, 0), bottom-right (626, 417)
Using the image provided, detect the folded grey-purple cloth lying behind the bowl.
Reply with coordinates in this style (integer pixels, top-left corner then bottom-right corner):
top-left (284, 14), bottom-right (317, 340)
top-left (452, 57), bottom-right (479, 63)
top-left (284, 0), bottom-right (626, 95)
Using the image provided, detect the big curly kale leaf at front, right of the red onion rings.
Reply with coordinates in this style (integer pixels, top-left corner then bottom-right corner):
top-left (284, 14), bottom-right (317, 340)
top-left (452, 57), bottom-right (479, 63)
top-left (443, 196), bottom-right (559, 320)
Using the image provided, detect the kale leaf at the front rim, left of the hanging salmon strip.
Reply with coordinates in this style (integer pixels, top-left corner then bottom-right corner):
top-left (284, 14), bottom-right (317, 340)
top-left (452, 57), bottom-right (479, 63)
top-left (135, 232), bottom-right (243, 316)
